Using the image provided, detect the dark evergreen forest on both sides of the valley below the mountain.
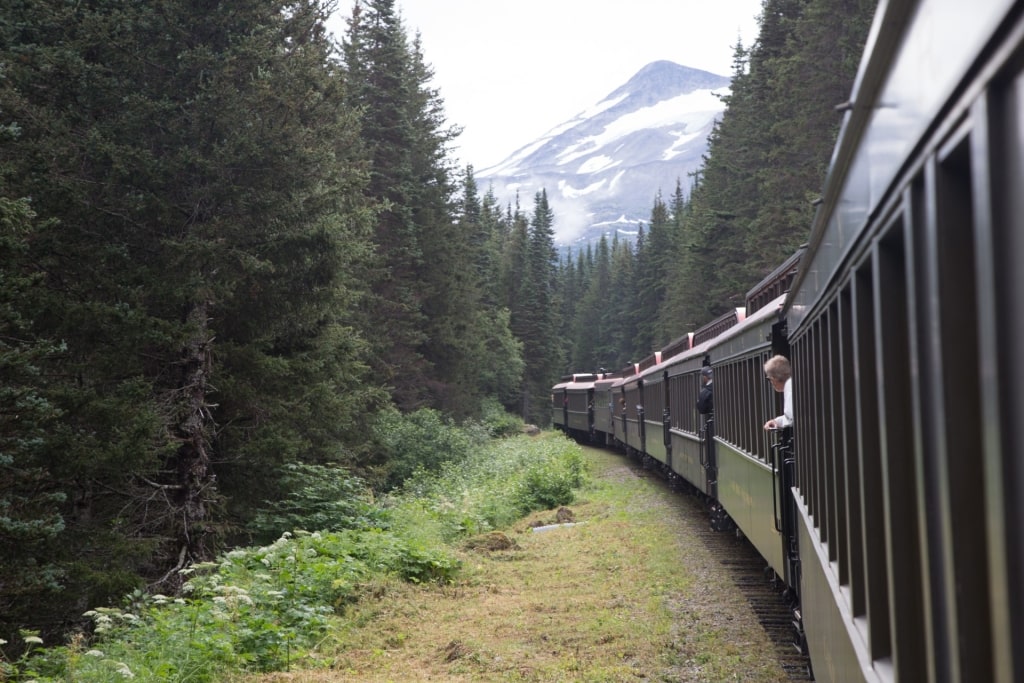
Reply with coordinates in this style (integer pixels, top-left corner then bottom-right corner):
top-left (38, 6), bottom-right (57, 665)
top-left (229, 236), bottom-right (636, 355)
top-left (0, 0), bottom-right (873, 659)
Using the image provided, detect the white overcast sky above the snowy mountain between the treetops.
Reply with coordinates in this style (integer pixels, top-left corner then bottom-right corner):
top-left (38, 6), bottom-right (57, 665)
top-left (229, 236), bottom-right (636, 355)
top-left (331, 0), bottom-right (761, 170)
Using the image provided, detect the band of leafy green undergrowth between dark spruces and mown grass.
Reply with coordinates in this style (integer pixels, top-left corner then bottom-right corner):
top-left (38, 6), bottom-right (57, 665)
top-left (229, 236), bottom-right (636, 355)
top-left (0, 434), bottom-right (586, 683)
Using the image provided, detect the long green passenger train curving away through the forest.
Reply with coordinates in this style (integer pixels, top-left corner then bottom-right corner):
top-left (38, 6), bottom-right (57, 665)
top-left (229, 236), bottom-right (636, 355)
top-left (551, 0), bottom-right (1024, 683)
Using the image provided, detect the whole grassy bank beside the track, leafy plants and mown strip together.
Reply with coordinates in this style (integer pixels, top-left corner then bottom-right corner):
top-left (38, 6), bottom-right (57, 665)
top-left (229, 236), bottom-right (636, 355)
top-left (6, 433), bottom-right (784, 683)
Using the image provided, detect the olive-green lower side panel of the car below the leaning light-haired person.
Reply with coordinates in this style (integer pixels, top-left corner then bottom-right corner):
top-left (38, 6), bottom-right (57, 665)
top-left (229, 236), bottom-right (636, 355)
top-left (716, 440), bottom-right (785, 577)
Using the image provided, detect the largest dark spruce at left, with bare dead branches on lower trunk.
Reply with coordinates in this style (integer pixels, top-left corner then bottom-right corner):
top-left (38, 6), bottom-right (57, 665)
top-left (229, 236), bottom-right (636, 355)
top-left (0, 0), bottom-right (374, 634)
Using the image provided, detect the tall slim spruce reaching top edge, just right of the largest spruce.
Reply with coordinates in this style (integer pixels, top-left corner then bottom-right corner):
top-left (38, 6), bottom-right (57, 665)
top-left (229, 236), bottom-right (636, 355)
top-left (343, 0), bottom-right (432, 410)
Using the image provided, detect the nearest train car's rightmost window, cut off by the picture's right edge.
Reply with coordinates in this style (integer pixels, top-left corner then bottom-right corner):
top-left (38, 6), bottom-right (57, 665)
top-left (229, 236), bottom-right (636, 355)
top-left (974, 61), bottom-right (1024, 680)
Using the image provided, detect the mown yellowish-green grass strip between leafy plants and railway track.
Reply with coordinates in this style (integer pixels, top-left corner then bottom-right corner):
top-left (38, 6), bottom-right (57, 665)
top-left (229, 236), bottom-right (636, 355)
top-left (239, 450), bottom-right (784, 683)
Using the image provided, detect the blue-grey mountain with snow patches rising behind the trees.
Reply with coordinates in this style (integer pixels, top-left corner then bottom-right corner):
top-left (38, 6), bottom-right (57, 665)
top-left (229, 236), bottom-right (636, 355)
top-left (476, 61), bottom-right (730, 245)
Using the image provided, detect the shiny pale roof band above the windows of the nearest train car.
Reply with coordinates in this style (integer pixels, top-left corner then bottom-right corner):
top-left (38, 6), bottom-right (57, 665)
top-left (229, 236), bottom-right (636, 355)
top-left (786, 0), bottom-right (1018, 333)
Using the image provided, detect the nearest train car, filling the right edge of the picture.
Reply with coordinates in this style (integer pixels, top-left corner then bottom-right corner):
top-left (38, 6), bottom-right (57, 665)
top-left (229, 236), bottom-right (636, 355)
top-left (785, 0), bottom-right (1024, 683)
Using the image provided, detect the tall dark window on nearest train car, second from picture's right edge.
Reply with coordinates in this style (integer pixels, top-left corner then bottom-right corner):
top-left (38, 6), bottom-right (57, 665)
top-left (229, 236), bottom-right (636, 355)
top-left (914, 127), bottom-right (991, 680)
